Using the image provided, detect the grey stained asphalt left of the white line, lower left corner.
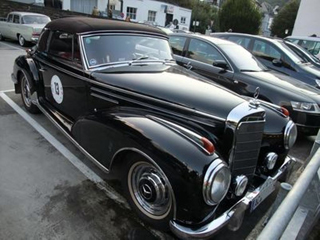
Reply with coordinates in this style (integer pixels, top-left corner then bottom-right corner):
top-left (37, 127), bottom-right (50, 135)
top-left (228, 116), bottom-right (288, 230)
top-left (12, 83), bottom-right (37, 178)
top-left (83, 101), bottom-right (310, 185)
top-left (0, 93), bottom-right (162, 239)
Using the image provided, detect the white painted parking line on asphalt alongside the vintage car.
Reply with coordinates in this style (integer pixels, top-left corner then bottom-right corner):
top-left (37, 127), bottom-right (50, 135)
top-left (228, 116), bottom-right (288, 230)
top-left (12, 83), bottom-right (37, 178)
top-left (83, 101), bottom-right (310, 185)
top-left (0, 91), bottom-right (129, 205)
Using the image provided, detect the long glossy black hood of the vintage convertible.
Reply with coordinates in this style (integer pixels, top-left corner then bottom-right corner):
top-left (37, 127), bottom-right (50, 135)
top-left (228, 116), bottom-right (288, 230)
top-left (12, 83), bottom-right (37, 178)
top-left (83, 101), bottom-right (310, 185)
top-left (92, 65), bottom-right (245, 119)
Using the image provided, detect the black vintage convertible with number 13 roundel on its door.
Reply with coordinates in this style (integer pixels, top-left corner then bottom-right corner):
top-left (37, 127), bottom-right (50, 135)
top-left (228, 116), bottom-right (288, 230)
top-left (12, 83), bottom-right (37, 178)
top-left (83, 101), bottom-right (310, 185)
top-left (12, 17), bottom-right (297, 239)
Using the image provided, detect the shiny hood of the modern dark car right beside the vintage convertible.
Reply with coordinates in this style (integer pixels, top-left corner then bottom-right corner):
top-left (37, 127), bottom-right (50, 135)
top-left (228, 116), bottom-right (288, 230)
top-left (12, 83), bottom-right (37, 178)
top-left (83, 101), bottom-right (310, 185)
top-left (243, 71), bottom-right (320, 99)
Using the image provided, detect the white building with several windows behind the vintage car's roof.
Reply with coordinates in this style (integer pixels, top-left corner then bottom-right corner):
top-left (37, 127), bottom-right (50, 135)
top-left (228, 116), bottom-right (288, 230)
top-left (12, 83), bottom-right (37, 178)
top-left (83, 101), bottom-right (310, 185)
top-left (62, 0), bottom-right (192, 30)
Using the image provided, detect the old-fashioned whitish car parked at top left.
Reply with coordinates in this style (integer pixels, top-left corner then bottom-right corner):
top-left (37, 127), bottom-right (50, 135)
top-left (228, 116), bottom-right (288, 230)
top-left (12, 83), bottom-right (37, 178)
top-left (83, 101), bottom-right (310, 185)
top-left (0, 12), bottom-right (51, 46)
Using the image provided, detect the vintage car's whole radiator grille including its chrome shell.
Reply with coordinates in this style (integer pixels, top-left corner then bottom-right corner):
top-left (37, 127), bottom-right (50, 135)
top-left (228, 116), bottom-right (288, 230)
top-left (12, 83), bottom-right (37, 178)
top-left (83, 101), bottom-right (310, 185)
top-left (226, 102), bottom-right (265, 179)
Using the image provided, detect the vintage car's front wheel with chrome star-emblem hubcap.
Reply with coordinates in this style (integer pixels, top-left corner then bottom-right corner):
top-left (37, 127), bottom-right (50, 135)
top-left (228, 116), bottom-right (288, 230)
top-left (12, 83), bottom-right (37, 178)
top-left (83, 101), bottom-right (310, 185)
top-left (123, 156), bottom-right (173, 231)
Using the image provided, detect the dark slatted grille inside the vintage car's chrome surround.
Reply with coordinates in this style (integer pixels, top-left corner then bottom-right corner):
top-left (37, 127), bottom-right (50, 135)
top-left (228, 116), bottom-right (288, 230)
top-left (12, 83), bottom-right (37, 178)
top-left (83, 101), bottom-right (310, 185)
top-left (229, 121), bottom-right (265, 178)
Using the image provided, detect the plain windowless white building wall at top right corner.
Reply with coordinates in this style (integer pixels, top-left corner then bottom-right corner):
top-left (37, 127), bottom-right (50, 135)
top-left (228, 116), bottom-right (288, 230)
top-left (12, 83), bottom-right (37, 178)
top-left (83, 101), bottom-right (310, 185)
top-left (292, 0), bottom-right (320, 36)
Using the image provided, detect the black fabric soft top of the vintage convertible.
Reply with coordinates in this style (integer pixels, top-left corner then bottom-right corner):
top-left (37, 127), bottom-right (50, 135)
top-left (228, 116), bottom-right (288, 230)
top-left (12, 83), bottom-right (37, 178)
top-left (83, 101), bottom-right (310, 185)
top-left (46, 17), bottom-right (166, 36)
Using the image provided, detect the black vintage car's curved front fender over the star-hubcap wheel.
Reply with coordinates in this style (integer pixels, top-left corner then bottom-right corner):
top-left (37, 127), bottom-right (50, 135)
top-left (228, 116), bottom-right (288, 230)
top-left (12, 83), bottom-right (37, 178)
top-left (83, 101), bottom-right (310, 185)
top-left (72, 110), bottom-right (218, 223)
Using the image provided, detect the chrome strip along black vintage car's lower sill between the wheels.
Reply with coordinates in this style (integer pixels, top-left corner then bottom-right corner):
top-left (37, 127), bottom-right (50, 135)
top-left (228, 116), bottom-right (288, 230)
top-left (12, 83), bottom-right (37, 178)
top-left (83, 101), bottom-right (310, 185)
top-left (36, 101), bottom-right (109, 173)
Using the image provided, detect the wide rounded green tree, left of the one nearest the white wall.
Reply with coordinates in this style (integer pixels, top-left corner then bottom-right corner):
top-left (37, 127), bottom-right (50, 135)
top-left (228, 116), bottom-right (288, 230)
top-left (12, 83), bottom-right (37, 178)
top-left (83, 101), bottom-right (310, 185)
top-left (219, 0), bottom-right (262, 34)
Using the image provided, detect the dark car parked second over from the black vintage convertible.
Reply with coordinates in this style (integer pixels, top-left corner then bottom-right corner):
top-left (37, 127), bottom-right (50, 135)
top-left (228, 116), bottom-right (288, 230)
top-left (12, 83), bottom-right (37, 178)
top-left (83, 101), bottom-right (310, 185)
top-left (211, 33), bottom-right (320, 88)
